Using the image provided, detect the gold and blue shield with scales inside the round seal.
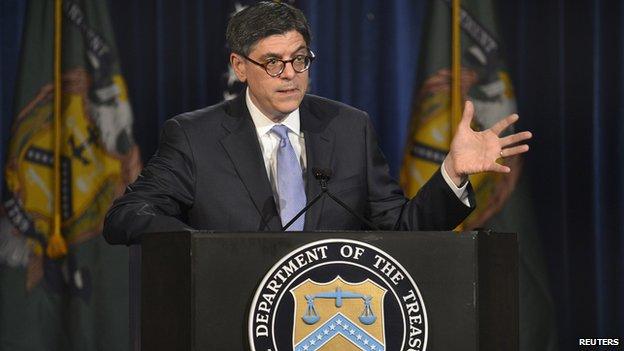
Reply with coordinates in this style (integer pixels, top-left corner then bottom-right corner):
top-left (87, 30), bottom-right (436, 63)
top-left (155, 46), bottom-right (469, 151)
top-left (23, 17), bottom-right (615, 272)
top-left (290, 276), bottom-right (387, 351)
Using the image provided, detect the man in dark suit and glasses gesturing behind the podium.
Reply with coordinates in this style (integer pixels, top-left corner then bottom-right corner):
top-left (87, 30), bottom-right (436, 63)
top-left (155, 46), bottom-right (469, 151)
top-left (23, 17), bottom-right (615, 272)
top-left (104, 2), bottom-right (531, 244)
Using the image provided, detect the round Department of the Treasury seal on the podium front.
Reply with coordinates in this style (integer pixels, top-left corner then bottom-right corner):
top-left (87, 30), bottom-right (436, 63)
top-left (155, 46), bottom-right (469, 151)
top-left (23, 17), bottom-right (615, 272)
top-left (248, 239), bottom-right (428, 351)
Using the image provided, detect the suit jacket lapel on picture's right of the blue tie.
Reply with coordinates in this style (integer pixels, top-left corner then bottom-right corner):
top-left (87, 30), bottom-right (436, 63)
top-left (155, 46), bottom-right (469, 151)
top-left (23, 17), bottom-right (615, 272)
top-left (299, 99), bottom-right (334, 231)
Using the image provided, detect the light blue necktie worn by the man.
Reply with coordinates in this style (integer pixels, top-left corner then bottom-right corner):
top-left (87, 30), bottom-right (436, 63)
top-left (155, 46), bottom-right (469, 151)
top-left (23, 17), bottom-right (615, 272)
top-left (271, 124), bottom-right (306, 231)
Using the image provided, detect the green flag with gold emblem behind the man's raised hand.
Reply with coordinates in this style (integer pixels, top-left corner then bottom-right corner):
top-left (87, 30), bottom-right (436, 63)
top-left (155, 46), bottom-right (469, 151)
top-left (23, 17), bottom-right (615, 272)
top-left (401, 0), bottom-right (557, 351)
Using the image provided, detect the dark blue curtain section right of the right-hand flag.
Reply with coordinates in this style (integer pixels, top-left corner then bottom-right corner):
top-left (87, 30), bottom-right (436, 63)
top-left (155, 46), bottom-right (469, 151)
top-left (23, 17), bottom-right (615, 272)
top-left (500, 0), bottom-right (624, 350)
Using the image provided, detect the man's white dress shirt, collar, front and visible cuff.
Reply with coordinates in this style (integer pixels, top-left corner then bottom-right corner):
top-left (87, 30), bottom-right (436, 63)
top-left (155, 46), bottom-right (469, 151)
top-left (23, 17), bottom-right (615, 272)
top-left (245, 88), bottom-right (470, 206)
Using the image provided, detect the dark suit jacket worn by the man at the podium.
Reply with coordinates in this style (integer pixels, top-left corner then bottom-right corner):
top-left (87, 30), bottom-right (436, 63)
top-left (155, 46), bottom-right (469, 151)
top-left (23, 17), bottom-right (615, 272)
top-left (104, 94), bottom-right (474, 244)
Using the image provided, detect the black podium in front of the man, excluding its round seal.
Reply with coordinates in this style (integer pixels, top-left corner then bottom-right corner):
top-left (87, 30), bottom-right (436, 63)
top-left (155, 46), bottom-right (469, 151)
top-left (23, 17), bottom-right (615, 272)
top-left (131, 232), bottom-right (518, 351)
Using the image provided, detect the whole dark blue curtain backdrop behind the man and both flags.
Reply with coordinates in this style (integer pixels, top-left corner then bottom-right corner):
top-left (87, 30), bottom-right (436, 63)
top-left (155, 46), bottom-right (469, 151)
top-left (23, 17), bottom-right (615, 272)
top-left (0, 0), bottom-right (624, 350)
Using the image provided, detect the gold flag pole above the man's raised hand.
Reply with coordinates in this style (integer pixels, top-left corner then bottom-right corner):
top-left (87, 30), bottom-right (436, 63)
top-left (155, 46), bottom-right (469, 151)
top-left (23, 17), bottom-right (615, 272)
top-left (449, 0), bottom-right (462, 139)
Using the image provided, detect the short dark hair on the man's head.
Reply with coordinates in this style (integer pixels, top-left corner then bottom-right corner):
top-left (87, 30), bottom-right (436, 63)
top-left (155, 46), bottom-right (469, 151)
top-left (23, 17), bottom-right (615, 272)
top-left (225, 1), bottom-right (311, 55)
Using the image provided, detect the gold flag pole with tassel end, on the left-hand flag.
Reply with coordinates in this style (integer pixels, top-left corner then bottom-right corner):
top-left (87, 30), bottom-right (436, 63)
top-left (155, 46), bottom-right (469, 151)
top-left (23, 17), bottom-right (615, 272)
top-left (46, 0), bottom-right (67, 259)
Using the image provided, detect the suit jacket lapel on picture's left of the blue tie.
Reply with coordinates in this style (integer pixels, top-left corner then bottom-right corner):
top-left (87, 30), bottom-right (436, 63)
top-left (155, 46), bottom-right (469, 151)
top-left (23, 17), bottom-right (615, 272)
top-left (221, 93), bottom-right (282, 231)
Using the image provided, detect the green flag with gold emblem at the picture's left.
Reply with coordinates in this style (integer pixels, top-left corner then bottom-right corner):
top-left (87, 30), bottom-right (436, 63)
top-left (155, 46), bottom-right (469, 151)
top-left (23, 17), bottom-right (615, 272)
top-left (0, 0), bottom-right (140, 351)
